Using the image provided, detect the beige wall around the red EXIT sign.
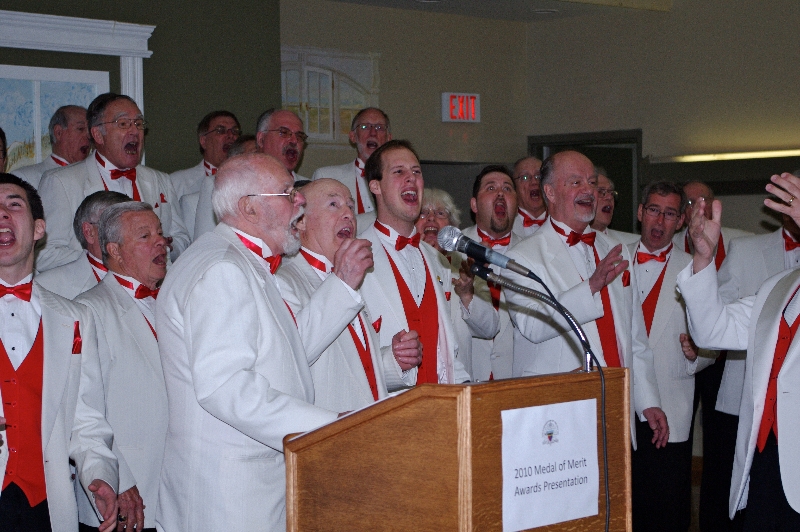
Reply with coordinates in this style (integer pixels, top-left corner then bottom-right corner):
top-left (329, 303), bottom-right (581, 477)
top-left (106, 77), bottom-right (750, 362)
top-left (281, 0), bottom-right (527, 177)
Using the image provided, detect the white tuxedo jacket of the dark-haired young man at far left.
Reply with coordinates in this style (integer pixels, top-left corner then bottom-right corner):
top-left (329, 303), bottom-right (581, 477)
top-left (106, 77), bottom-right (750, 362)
top-left (0, 283), bottom-right (118, 532)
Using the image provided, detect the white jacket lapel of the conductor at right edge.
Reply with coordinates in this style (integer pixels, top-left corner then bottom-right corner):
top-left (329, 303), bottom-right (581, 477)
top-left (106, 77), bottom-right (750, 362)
top-left (748, 269), bottom-right (800, 400)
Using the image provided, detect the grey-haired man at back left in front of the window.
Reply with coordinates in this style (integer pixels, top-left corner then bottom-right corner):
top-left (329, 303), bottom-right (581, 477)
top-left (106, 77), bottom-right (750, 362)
top-left (14, 105), bottom-right (90, 188)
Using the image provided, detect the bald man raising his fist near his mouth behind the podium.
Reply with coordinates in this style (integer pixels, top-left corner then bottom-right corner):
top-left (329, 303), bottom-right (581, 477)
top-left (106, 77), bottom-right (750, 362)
top-left (278, 179), bottom-right (386, 412)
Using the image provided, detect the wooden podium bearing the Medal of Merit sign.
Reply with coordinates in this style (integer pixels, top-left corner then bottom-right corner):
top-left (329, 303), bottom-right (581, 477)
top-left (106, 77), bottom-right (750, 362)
top-left (284, 368), bottom-right (631, 532)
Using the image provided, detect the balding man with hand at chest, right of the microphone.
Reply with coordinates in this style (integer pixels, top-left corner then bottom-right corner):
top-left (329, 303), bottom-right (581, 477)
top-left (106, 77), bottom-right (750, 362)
top-left (506, 151), bottom-right (669, 449)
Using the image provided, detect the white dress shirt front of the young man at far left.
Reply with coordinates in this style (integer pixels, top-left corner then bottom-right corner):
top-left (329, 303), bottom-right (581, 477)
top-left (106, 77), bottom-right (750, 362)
top-left (0, 274), bottom-right (42, 369)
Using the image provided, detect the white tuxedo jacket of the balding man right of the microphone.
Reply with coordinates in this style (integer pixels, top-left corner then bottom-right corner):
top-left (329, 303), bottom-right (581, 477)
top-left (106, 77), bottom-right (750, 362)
top-left (505, 222), bottom-right (661, 449)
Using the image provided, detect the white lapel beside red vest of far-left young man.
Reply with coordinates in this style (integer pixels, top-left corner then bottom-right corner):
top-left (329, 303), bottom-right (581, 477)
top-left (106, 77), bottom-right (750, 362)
top-left (34, 283), bottom-right (75, 449)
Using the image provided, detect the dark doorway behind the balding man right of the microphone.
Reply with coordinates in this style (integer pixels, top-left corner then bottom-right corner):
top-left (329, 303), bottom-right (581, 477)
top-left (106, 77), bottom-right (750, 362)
top-left (528, 129), bottom-right (642, 232)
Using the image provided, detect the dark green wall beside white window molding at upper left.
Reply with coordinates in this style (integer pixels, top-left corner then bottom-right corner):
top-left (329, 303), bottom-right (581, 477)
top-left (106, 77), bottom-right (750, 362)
top-left (0, 0), bottom-right (281, 172)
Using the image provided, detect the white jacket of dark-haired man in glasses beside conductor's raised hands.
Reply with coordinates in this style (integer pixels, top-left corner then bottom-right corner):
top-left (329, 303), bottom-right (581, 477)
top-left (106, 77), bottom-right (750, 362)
top-left (628, 242), bottom-right (713, 443)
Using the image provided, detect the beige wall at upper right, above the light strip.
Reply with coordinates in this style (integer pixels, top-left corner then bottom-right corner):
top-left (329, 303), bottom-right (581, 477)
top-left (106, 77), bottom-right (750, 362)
top-left (527, 0), bottom-right (800, 156)
